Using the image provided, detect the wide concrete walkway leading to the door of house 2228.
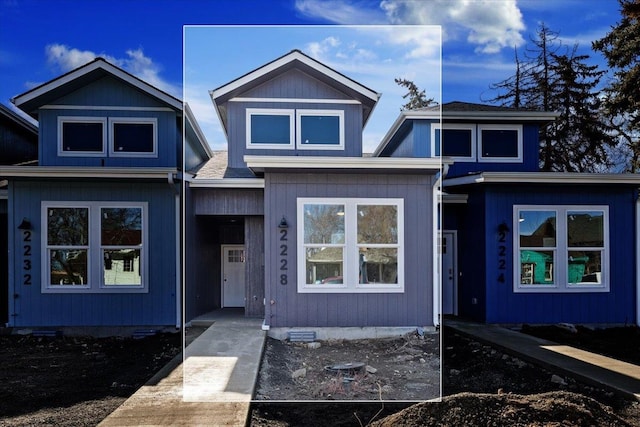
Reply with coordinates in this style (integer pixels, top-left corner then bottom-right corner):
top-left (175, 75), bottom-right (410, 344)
top-left (99, 316), bottom-right (266, 427)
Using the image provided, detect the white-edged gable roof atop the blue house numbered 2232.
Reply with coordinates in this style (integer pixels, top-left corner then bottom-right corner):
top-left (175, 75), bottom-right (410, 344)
top-left (11, 58), bottom-right (182, 118)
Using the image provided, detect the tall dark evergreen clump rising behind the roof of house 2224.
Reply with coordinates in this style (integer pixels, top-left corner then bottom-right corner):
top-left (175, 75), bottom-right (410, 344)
top-left (489, 24), bottom-right (612, 172)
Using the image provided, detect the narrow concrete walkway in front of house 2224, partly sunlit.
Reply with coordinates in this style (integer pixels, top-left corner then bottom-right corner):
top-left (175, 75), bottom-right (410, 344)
top-left (444, 319), bottom-right (640, 400)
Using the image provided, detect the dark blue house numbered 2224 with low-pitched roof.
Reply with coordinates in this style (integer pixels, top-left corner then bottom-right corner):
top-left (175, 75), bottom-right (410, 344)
top-left (376, 102), bottom-right (640, 324)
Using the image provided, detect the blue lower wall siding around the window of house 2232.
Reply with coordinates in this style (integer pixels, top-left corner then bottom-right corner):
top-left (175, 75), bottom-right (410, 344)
top-left (9, 180), bottom-right (179, 327)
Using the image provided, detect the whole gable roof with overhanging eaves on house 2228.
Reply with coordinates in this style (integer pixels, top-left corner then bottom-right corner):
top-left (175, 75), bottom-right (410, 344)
top-left (209, 49), bottom-right (380, 137)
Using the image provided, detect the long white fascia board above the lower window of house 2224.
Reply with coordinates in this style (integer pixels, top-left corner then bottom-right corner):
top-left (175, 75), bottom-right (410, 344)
top-left (443, 172), bottom-right (640, 187)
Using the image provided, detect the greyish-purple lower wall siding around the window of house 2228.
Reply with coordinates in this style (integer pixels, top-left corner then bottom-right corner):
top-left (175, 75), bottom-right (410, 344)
top-left (264, 172), bottom-right (434, 327)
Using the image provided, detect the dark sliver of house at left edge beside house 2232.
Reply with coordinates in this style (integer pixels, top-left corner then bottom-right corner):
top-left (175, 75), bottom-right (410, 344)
top-left (0, 104), bottom-right (38, 325)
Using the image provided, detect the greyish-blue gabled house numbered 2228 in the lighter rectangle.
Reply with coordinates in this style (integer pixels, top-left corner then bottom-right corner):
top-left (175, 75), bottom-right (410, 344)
top-left (185, 50), bottom-right (441, 329)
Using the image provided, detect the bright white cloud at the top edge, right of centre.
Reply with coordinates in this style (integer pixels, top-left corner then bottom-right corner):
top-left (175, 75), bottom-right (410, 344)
top-left (296, 0), bottom-right (525, 56)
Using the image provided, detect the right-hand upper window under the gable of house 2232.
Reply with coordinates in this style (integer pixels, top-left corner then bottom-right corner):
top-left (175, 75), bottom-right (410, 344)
top-left (109, 117), bottom-right (158, 157)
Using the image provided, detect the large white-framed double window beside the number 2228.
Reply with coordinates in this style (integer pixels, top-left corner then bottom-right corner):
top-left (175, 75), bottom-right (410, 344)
top-left (298, 199), bottom-right (404, 292)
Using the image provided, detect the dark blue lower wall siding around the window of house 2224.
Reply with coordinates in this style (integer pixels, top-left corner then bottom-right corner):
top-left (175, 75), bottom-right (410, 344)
top-left (486, 185), bottom-right (637, 323)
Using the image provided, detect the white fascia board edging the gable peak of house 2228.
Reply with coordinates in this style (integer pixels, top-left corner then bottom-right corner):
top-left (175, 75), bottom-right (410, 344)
top-left (210, 51), bottom-right (380, 102)
